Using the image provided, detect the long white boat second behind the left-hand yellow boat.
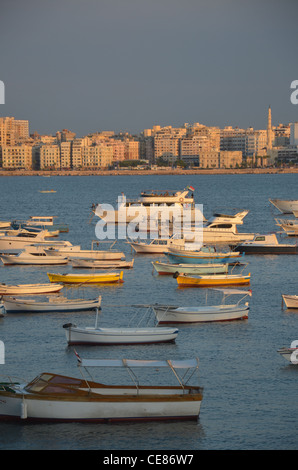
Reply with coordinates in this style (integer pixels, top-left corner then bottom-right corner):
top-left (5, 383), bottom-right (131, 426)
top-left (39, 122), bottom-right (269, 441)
top-left (45, 240), bottom-right (125, 260)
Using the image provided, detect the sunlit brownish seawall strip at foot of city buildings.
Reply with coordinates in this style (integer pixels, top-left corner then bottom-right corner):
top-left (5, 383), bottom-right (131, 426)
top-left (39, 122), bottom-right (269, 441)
top-left (0, 168), bottom-right (298, 176)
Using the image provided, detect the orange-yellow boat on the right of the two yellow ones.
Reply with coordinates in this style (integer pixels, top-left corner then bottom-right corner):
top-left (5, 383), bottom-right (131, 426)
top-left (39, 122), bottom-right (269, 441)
top-left (174, 273), bottom-right (250, 287)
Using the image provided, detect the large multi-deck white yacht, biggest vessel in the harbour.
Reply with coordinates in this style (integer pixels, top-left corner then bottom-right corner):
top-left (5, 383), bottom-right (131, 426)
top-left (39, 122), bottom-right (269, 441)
top-left (92, 188), bottom-right (203, 224)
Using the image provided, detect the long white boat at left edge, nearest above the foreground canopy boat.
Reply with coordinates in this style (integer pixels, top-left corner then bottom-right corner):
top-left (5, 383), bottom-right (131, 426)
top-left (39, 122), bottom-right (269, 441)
top-left (2, 296), bottom-right (101, 313)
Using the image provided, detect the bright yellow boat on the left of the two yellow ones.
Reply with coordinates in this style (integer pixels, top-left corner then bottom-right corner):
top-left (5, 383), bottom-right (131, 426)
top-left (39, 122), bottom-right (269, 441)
top-left (47, 271), bottom-right (124, 284)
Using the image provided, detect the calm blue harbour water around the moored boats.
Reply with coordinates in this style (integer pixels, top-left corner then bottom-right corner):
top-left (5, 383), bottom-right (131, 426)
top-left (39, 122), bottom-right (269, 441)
top-left (0, 175), bottom-right (298, 450)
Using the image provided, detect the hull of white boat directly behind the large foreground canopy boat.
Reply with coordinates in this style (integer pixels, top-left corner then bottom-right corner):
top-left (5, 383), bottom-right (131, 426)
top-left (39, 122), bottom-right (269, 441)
top-left (64, 325), bottom-right (178, 345)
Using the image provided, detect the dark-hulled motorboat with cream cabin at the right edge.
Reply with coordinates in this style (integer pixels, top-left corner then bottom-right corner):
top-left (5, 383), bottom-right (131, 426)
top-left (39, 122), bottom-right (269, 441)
top-left (235, 233), bottom-right (298, 255)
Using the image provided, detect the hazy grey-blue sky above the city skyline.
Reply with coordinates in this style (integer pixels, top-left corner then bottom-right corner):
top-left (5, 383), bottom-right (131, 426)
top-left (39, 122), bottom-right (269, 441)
top-left (0, 0), bottom-right (298, 136)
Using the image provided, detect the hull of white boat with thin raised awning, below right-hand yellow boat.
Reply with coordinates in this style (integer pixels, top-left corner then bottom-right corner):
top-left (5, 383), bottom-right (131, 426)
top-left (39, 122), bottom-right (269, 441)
top-left (153, 304), bottom-right (249, 324)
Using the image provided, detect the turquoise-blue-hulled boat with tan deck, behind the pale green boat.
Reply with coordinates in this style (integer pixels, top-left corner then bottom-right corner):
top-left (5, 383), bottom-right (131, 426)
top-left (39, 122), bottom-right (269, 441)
top-left (165, 247), bottom-right (242, 264)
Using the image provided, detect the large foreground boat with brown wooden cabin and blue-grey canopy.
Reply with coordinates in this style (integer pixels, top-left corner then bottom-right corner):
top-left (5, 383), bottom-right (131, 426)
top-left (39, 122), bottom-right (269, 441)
top-left (0, 357), bottom-right (203, 423)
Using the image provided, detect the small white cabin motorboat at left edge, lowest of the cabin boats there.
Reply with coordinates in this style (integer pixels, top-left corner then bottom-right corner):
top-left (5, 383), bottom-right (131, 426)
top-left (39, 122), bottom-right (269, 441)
top-left (0, 245), bottom-right (68, 266)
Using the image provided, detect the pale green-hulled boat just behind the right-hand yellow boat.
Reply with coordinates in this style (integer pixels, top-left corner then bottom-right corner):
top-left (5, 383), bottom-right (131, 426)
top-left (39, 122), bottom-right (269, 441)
top-left (152, 261), bottom-right (229, 275)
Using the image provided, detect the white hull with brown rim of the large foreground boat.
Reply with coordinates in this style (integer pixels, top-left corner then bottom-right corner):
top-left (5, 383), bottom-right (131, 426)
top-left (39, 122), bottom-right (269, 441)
top-left (0, 390), bottom-right (202, 423)
